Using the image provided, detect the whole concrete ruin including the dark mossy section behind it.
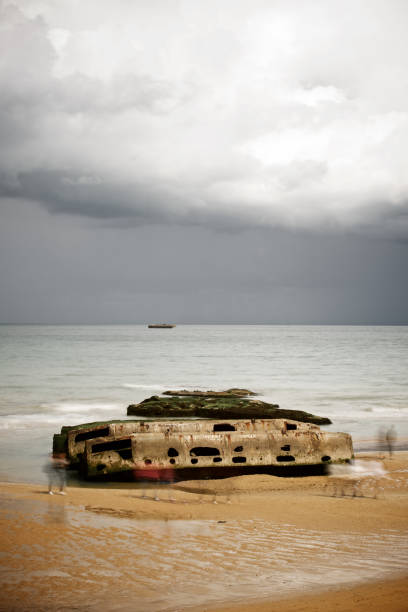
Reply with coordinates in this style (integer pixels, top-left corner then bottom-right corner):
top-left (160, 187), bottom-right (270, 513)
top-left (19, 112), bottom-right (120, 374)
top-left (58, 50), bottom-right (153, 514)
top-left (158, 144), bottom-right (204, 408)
top-left (53, 388), bottom-right (353, 478)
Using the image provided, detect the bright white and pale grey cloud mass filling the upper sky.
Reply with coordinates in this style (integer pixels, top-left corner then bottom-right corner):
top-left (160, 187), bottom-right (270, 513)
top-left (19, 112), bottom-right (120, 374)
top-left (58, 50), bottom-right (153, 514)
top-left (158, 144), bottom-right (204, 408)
top-left (0, 0), bottom-right (408, 235)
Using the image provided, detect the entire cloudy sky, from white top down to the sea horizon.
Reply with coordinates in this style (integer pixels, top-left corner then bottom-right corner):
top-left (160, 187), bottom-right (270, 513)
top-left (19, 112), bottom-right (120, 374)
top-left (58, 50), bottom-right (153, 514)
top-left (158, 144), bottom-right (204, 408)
top-left (0, 0), bottom-right (408, 324)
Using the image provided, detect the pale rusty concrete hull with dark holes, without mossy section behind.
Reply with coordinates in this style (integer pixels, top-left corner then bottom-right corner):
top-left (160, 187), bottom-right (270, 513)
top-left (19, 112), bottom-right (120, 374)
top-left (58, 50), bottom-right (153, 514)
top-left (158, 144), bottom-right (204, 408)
top-left (57, 419), bottom-right (353, 478)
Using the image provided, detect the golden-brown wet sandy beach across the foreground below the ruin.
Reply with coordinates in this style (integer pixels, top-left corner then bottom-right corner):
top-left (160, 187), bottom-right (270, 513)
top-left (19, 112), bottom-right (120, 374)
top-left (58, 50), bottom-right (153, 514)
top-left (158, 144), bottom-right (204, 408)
top-left (0, 452), bottom-right (408, 612)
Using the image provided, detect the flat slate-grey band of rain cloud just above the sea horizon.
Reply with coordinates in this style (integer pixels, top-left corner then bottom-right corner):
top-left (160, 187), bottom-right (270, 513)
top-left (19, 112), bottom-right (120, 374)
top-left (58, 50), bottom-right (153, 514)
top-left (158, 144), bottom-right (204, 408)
top-left (0, 200), bottom-right (408, 324)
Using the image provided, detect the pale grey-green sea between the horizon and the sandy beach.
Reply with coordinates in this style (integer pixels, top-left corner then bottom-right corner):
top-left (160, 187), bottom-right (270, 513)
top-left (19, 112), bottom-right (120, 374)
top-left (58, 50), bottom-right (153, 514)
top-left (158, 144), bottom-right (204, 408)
top-left (0, 325), bottom-right (408, 481)
